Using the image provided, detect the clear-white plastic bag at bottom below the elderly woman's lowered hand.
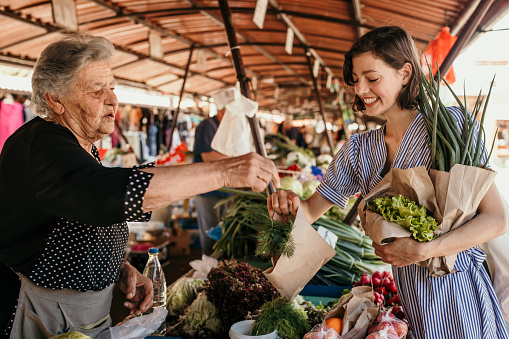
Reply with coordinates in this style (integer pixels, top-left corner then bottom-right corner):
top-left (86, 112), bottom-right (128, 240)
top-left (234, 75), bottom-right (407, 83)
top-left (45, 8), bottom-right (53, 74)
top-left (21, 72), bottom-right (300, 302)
top-left (97, 307), bottom-right (168, 339)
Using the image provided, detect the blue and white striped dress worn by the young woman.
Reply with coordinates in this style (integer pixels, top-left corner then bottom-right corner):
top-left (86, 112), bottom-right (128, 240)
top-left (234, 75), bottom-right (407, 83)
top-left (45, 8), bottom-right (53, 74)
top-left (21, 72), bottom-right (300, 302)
top-left (317, 107), bottom-right (508, 339)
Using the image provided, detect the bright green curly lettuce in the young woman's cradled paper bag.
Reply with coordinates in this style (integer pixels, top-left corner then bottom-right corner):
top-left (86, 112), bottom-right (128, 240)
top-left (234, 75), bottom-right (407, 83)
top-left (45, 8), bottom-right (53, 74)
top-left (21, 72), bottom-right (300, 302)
top-left (368, 194), bottom-right (438, 242)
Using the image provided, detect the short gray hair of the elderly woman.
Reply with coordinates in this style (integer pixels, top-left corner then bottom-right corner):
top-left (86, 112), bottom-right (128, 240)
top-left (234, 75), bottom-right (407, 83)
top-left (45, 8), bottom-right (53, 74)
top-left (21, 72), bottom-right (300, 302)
top-left (32, 33), bottom-right (115, 118)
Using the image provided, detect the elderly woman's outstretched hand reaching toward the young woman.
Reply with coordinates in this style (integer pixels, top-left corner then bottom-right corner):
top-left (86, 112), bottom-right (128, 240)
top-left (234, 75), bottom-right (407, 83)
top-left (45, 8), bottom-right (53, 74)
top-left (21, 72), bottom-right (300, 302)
top-left (218, 153), bottom-right (279, 192)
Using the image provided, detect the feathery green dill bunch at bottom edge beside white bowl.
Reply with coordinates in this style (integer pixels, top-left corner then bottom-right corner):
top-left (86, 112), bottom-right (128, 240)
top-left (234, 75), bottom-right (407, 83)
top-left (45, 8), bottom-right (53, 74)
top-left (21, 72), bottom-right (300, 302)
top-left (251, 297), bottom-right (311, 339)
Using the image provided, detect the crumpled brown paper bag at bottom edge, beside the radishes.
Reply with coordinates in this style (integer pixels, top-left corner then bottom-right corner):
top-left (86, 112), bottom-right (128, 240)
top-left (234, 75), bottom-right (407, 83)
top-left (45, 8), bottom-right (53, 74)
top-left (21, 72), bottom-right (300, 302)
top-left (323, 286), bottom-right (378, 339)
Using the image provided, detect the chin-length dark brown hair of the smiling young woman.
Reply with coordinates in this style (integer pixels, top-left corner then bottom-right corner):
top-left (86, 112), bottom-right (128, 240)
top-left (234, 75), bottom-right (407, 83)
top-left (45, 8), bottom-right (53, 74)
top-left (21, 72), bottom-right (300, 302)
top-left (343, 26), bottom-right (421, 111)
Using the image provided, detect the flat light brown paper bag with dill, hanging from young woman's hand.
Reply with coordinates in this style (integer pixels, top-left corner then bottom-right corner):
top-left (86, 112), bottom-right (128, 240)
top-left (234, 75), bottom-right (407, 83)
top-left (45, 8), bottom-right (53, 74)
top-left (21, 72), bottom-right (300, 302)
top-left (263, 209), bottom-right (336, 300)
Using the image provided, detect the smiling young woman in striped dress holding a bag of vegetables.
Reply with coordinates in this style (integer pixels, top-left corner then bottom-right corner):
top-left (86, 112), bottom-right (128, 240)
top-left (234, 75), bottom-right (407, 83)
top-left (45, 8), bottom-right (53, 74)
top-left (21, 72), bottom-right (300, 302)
top-left (267, 27), bottom-right (508, 339)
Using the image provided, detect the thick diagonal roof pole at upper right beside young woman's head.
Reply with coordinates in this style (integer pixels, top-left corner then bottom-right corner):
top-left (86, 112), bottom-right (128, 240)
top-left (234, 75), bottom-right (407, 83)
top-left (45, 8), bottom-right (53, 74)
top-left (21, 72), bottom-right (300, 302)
top-left (435, 0), bottom-right (493, 80)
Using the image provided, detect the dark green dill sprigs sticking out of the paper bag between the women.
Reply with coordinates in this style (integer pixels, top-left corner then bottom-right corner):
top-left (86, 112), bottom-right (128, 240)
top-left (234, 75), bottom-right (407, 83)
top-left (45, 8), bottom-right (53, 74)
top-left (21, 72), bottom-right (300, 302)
top-left (255, 218), bottom-right (295, 258)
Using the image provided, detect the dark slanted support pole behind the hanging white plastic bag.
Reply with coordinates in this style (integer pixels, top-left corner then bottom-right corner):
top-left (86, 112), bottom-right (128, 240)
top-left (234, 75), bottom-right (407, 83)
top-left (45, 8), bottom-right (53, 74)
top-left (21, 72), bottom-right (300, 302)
top-left (219, 0), bottom-right (275, 194)
